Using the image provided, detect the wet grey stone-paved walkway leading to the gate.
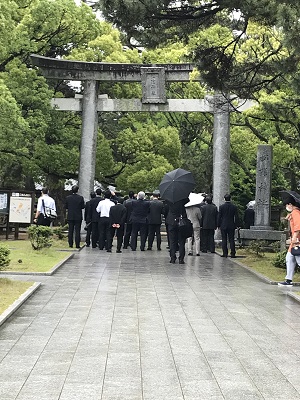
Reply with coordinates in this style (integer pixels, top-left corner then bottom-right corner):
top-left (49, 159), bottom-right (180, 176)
top-left (0, 246), bottom-right (300, 400)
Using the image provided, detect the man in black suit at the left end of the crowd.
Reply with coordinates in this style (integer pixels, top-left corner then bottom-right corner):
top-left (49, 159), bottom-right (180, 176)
top-left (66, 185), bottom-right (84, 249)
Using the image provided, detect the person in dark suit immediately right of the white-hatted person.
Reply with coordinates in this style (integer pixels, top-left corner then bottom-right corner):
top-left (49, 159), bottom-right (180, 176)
top-left (201, 196), bottom-right (218, 253)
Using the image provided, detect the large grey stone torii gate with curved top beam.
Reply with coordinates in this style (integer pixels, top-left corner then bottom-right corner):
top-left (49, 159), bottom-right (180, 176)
top-left (31, 54), bottom-right (253, 206)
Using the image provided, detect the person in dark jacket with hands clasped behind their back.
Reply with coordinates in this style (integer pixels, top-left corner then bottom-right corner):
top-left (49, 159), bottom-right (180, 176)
top-left (108, 199), bottom-right (127, 253)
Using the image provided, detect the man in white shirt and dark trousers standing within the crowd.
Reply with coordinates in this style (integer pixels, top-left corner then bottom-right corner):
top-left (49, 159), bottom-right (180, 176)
top-left (96, 190), bottom-right (115, 252)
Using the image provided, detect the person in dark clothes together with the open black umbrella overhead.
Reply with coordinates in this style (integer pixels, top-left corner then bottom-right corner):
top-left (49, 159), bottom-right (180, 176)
top-left (159, 168), bottom-right (195, 264)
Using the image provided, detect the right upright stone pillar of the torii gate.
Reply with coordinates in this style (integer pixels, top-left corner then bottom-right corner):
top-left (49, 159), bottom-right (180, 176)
top-left (213, 93), bottom-right (230, 207)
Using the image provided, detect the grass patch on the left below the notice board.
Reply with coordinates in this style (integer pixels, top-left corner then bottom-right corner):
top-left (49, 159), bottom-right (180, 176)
top-left (1, 240), bottom-right (71, 272)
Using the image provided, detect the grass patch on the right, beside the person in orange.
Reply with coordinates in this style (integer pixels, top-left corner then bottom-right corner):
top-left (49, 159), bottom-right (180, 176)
top-left (237, 249), bottom-right (300, 282)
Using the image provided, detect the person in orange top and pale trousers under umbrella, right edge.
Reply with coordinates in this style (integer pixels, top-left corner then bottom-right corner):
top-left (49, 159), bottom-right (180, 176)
top-left (278, 191), bottom-right (300, 287)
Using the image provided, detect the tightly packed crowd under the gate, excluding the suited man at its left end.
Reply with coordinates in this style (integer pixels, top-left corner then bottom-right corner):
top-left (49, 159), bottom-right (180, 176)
top-left (81, 189), bottom-right (239, 264)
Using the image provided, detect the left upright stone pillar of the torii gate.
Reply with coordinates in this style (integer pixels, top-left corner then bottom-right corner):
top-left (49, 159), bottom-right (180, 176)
top-left (78, 80), bottom-right (98, 201)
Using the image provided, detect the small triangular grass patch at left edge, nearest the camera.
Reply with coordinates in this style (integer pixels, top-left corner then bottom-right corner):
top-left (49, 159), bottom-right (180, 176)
top-left (0, 278), bottom-right (33, 314)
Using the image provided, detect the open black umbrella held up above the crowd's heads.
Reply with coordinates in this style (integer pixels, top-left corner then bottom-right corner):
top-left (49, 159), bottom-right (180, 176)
top-left (159, 168), bottom-right (195, 203)
